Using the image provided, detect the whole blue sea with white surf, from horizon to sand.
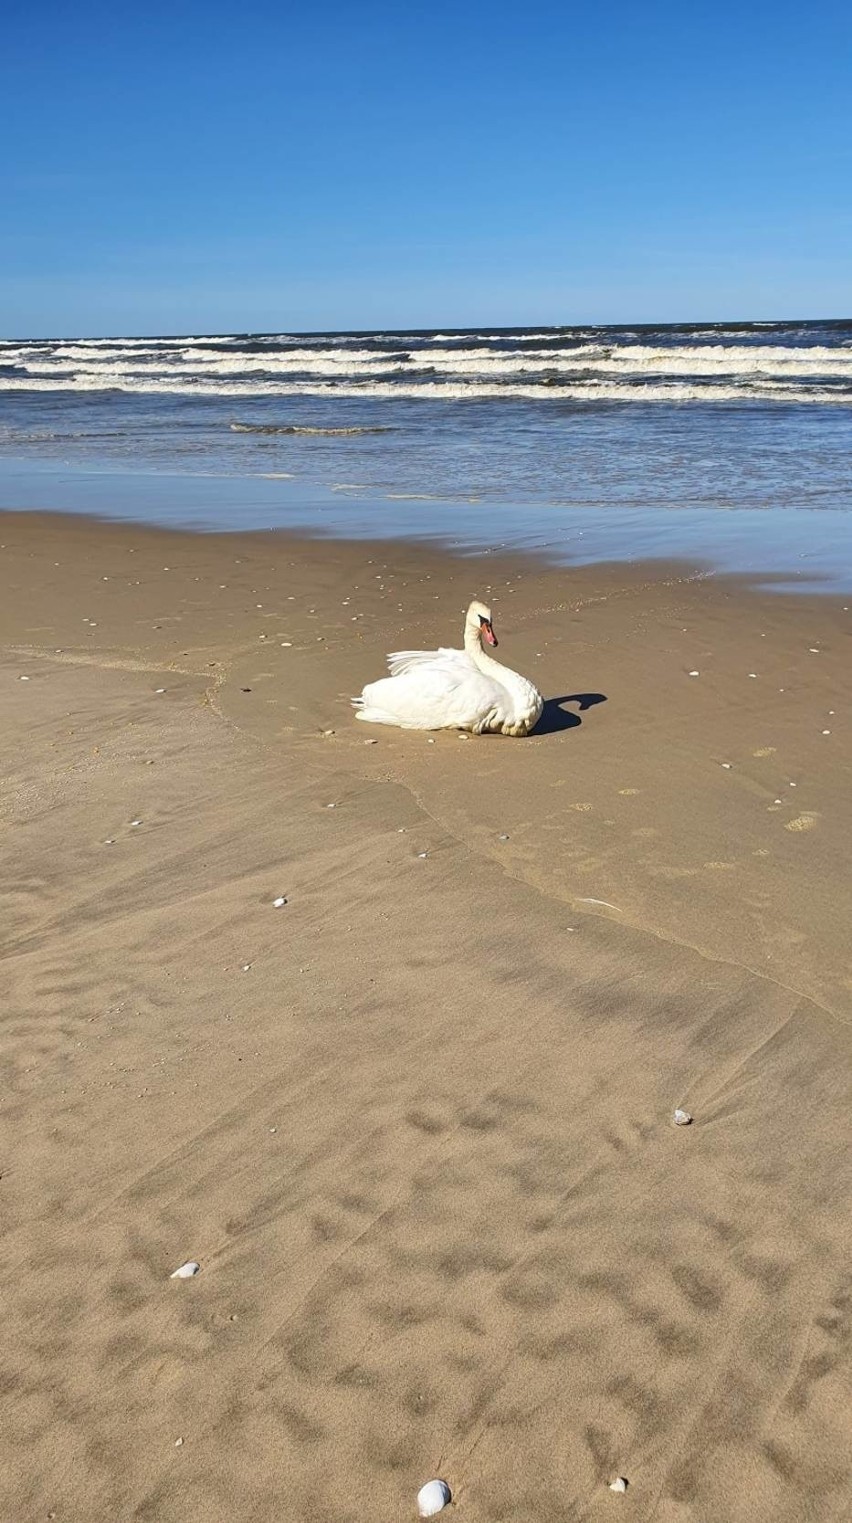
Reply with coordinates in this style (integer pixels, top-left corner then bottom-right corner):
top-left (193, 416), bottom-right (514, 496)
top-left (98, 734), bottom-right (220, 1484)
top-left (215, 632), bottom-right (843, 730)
top-left (0, 320), bottom-right (852, 591)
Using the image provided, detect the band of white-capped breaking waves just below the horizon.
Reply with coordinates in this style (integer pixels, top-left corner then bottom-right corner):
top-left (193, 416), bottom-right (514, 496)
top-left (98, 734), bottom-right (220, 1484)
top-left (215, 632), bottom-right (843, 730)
top-left (0, 323), bottom-right (852, 405)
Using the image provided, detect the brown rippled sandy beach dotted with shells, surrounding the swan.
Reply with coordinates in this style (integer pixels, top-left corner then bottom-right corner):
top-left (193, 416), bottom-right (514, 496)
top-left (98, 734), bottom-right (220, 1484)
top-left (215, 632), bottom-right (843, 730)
top-left (0, 515), bottom-right (852, 1523)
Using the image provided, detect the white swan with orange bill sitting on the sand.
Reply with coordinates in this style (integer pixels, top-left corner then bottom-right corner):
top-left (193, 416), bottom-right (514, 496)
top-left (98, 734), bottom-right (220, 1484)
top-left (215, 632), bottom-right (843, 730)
top-left (352, 602), bottom-right (544, 736)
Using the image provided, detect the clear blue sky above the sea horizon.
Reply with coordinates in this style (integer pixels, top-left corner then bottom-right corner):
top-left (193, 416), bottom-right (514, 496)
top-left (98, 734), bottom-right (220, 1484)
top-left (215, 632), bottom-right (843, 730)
top-left (0, 0), bottom-right (852, 337)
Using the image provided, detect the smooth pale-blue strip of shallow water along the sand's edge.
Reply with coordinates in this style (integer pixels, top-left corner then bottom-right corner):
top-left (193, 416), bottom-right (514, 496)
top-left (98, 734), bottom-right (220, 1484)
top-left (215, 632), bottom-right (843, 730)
top-left (0, 455), bottom-right (852, 597)
